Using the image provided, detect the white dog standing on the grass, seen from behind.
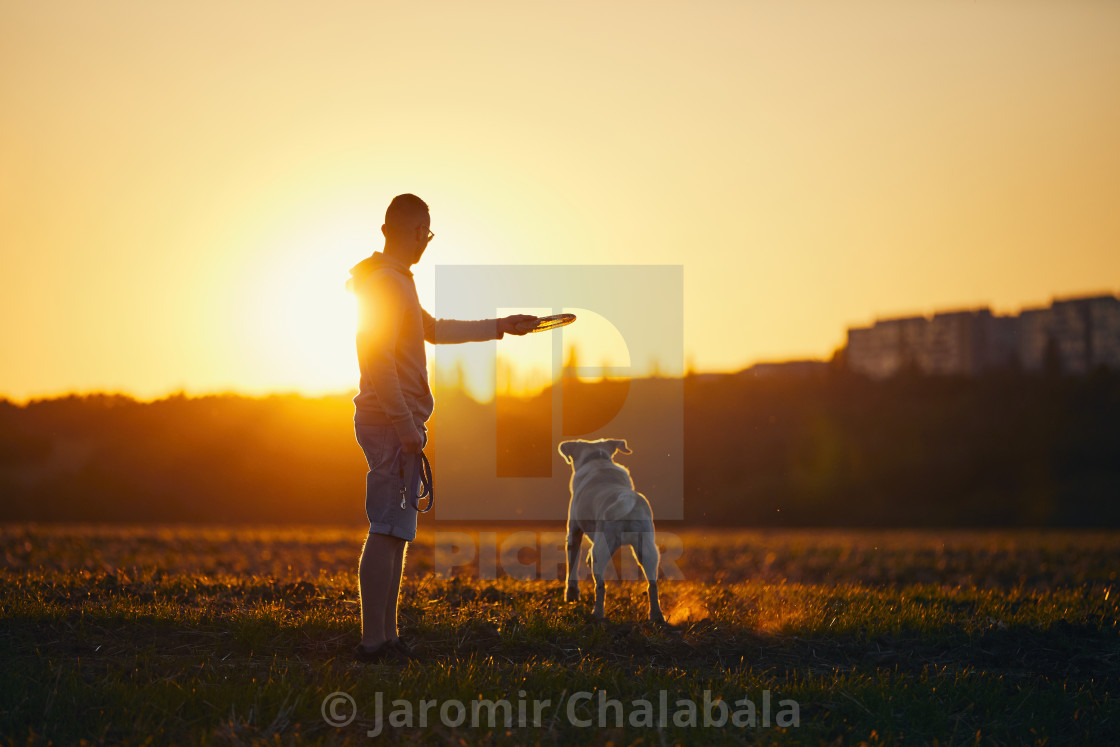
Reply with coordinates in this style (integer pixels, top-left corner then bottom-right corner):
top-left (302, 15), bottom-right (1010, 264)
top-left (559, 438), bottom-right (665, 623)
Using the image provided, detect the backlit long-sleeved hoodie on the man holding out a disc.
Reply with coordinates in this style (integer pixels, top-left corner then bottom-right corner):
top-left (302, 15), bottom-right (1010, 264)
top-left (346, 252), bottom-right (502, 435)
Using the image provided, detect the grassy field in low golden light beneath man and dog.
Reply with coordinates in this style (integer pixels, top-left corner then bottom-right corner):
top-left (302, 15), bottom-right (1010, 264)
top-left (0, 526), bottom-right (1120, 745)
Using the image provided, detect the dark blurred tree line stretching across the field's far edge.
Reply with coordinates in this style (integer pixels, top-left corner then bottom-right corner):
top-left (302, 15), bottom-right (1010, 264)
top-left (0, 371), bottom-right (1120, 526)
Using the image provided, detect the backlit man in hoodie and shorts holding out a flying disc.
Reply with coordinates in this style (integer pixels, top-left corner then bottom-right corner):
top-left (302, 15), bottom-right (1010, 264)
top-left (346, 195), bottom-right (536, 662)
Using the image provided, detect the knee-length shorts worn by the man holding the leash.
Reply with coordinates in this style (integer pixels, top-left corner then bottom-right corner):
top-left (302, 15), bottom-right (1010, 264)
top-left (354, 423), bottom-right (428, 542)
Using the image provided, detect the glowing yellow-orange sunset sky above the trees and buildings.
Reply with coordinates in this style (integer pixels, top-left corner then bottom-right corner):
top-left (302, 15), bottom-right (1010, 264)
top-left (0, 0), bottom-right (1120, 400)
